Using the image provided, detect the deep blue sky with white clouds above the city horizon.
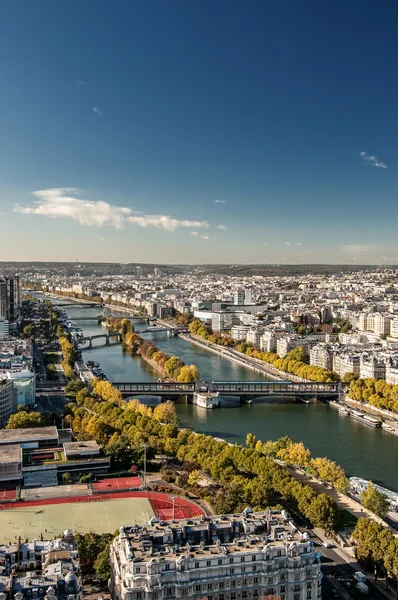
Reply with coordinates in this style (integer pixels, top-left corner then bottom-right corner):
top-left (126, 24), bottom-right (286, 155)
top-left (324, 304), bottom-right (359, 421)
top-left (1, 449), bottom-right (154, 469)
top-left (0, 0), bottom-right (398, 264)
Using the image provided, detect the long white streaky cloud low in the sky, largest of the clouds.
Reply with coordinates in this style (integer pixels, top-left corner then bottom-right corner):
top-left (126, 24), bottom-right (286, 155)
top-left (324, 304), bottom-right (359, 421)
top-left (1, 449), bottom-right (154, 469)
top-left (14, 188), bottom-right (209, 232)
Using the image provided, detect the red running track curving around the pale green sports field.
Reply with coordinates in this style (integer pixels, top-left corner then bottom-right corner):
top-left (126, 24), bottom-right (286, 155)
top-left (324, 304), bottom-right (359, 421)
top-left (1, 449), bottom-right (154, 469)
top-left (0, 492), bottom-right (204, 521)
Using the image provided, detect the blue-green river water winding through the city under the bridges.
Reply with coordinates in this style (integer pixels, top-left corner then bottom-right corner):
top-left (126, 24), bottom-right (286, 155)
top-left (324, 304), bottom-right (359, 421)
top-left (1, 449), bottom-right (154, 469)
top-left (38, 301), bottom-right (398, 491)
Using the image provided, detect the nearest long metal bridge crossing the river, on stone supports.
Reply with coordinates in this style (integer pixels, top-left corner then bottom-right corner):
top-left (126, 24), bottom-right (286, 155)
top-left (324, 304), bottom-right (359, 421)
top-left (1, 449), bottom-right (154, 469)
top-left (112, 380), bottom-right (340, 399)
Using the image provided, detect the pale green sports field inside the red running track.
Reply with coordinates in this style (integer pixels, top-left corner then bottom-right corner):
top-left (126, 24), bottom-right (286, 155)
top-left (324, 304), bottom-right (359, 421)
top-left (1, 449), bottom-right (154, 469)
top-left (0, 498), bottom-right (155, 543)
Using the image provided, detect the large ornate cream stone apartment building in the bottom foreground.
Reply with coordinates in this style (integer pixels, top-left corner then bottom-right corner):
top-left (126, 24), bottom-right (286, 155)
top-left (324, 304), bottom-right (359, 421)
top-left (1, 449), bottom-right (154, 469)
top-left (111, 508), bottom-right (321, 600)
